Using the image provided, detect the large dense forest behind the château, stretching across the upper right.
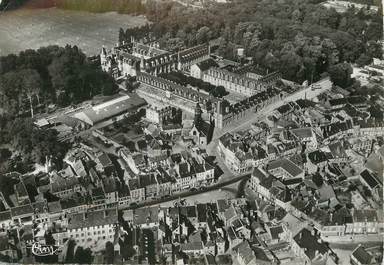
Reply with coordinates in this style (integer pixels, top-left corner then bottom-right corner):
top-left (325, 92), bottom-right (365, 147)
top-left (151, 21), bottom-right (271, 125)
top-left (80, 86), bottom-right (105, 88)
top-left (120, 0), bottom-right (383, 82)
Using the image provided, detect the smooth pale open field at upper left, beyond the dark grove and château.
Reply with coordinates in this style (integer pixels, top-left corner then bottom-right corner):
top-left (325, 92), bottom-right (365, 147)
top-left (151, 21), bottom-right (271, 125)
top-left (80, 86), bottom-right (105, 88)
top-left (0, 8), bottom-right (147, 56)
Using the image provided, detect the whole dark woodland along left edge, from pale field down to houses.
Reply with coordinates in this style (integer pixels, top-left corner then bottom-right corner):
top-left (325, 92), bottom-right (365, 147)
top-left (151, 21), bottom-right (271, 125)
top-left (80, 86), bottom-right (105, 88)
top-left (0, 46), bottom-right (117, 173)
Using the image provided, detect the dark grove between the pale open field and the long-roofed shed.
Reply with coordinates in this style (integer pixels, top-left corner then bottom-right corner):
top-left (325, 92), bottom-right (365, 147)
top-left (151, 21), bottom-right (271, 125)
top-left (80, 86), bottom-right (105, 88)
top-left (0, 46), bottom-right (117, 116)
